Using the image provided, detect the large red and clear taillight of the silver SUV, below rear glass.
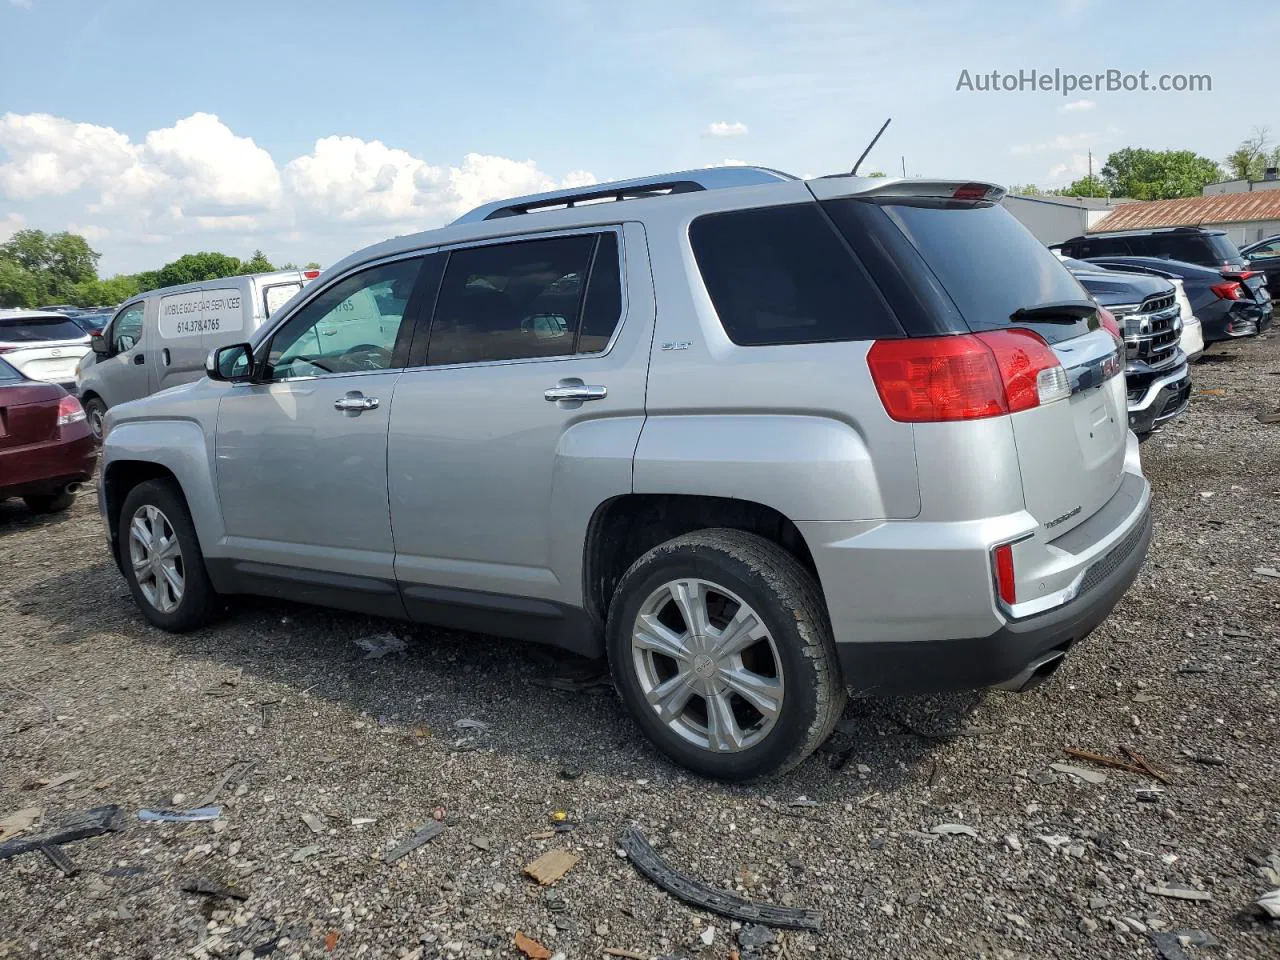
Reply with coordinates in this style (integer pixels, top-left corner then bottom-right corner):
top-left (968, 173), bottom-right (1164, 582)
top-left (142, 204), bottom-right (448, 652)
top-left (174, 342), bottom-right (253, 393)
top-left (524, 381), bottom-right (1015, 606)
top-left (867, 329), bottom-right (1071, 424)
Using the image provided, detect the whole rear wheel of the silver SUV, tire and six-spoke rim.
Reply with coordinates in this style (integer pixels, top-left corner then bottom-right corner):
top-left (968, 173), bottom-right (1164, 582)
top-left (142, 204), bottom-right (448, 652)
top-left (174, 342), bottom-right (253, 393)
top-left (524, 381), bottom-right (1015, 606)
top-left (607, 529), bottom-right (847, 781)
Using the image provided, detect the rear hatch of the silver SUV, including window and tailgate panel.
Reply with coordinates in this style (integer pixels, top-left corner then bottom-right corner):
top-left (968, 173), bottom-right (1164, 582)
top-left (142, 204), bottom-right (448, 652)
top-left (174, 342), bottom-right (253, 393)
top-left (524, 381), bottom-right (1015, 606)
top-left (812, 180), bottom-right (1129, 536)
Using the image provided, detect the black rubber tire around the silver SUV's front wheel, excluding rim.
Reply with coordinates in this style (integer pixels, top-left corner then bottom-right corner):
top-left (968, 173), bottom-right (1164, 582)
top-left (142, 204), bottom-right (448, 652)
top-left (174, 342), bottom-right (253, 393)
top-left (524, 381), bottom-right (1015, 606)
top-left (119, 480), bottom-right (223, 634)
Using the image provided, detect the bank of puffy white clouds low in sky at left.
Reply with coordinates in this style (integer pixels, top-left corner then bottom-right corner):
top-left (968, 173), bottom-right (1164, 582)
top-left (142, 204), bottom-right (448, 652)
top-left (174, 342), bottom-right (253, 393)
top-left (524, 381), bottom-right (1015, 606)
top-left (0, 113), bottom-right (596, 269)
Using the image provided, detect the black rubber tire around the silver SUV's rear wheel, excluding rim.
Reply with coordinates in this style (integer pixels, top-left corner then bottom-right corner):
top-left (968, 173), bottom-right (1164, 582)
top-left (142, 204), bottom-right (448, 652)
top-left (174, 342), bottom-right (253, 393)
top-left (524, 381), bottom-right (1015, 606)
top-left (605, 529), bottom-right (847, 781)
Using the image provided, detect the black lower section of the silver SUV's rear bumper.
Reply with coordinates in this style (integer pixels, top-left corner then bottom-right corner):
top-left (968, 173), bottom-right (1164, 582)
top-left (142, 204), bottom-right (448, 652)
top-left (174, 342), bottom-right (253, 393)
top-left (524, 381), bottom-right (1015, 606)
top-left (836, 506), bottom-right (1152, 695)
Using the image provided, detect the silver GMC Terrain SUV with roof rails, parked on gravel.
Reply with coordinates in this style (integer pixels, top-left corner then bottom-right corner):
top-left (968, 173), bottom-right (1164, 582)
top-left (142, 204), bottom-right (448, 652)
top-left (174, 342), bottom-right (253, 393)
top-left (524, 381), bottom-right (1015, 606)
top-left (100, 168), bottom-right (1151, 780)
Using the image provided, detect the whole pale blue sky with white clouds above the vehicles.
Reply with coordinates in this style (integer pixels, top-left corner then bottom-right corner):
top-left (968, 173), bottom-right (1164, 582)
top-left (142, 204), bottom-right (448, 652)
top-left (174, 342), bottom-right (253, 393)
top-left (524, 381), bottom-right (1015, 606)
top-left (0, 0), bottom-right (1280, 273)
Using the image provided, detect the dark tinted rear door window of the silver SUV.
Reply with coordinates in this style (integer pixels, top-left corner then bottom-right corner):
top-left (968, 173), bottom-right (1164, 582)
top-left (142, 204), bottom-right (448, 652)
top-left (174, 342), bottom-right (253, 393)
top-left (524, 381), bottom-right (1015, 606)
top-left (426, 234), bottom-right (598, 365)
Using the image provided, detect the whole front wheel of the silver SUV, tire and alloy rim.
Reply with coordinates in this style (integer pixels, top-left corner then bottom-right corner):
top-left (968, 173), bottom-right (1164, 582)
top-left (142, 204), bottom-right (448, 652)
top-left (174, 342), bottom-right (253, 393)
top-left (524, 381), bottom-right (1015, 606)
top-left (119, 480), bottom-right (219, 634)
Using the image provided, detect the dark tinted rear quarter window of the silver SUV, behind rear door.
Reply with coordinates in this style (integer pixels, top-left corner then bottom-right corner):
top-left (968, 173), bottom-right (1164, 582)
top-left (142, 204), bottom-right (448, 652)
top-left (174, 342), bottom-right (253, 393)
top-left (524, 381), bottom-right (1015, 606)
top-left (689, 204), bottom-right (902, 346)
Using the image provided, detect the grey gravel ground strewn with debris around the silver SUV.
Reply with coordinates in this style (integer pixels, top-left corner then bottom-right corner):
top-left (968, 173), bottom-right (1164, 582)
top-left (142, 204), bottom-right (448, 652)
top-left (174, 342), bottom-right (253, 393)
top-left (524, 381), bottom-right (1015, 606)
top-left (0, 337), bottom-right (1280, 960)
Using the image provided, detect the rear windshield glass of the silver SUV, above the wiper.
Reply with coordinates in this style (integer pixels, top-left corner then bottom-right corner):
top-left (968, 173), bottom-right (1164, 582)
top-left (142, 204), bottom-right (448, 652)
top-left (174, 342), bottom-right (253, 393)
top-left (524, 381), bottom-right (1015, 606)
top-left (875, 200), bottom-right (1097, 343)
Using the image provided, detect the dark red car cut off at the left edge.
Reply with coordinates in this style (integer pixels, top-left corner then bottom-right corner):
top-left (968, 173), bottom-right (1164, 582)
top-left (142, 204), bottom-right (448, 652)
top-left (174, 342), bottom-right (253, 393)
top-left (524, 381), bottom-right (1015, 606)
top-left (0, 360), bottom-right (97, 513)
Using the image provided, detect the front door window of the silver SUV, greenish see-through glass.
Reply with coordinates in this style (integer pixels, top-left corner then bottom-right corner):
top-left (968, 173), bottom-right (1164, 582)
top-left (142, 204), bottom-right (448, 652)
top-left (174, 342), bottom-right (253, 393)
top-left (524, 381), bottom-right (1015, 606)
top-left (268, 260), bottom-right (422, 380)
